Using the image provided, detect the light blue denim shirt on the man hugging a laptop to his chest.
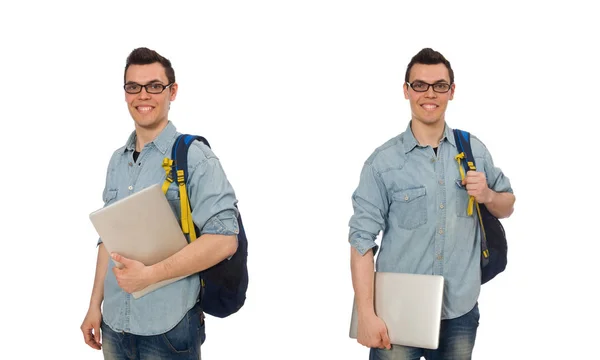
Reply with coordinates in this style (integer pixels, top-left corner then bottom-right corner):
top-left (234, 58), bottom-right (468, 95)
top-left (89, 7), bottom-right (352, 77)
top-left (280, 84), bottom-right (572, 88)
top-left (98, 121), bottom-right (238, 335)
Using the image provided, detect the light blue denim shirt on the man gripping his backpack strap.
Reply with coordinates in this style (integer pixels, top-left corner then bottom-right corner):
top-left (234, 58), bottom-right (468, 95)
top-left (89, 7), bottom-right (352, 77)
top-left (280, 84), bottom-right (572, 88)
top-left (349, 122), bottom-right (512, 319)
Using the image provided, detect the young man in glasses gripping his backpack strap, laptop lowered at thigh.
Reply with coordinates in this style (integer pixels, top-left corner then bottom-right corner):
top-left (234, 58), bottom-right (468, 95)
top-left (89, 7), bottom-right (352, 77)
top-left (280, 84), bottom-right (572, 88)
top-left (349, 48), bottom-right (515, 360)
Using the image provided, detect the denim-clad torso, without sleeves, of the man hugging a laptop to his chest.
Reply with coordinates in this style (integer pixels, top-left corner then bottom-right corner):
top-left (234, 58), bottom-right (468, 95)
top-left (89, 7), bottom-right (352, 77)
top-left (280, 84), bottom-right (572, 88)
top-left (103, 127), bottom-right (200, 335)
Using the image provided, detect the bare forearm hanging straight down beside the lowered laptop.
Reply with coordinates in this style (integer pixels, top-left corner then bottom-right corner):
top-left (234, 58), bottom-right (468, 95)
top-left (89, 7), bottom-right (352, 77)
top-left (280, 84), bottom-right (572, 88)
top-left (350, 246), bottom-right (375, 316)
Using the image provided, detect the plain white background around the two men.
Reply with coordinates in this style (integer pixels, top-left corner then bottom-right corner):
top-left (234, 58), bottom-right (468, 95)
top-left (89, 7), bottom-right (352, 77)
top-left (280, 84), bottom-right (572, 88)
top-left (0, 0), bottom-right (600, 359)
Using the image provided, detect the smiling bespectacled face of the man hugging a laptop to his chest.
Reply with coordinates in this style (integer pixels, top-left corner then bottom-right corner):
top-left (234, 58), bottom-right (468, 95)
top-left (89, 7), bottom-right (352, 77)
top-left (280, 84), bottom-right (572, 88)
top-left (125, 62), bottom-right (177, 130)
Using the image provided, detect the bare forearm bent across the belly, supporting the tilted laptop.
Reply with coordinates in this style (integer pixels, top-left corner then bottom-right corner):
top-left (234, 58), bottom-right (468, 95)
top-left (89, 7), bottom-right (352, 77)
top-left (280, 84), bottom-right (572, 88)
top-left (151, 234), bottom-right (237, 283)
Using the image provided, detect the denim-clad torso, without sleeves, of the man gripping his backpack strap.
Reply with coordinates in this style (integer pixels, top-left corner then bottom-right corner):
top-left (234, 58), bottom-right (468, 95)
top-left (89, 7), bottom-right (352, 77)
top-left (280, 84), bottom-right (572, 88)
top-left (372, 126), bottom-right (483, 318)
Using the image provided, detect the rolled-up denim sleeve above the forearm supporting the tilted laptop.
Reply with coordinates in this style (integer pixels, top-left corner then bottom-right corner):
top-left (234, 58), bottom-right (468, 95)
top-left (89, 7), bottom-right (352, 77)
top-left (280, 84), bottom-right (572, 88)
top-left (188, 157), bottom-right (239, 235)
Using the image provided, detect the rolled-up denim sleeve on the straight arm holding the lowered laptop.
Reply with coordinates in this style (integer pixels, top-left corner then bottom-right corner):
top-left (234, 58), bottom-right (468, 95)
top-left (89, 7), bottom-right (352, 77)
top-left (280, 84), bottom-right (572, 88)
top-left (348, 164), bottom-right (389, 255)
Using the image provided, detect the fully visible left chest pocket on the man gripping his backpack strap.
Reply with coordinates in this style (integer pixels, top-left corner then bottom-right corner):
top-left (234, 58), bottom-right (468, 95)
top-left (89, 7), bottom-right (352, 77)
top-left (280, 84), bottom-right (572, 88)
top-left (391, 186), bottom-right (427, 229)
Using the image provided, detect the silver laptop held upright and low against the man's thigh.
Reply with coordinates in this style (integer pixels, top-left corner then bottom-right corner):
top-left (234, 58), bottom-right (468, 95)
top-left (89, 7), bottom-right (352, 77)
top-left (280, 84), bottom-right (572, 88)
top-left (350, 272), bottom-right (444, 349)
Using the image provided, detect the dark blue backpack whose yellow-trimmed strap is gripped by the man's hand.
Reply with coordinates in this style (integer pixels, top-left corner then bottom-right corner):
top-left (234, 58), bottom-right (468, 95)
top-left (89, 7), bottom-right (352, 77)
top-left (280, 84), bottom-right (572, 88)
top-left (454, 129), bottom-right (508, 284)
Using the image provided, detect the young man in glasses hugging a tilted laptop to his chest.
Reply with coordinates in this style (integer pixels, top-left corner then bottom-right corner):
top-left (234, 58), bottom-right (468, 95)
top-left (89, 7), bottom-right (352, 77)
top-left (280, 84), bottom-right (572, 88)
top-left (81, 48), bottom-right (238, 359)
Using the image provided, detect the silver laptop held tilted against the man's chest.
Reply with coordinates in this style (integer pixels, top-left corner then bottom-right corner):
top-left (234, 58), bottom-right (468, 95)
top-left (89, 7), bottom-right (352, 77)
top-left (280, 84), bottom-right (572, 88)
top-left (90, 184), bottom-right (187, 299)
